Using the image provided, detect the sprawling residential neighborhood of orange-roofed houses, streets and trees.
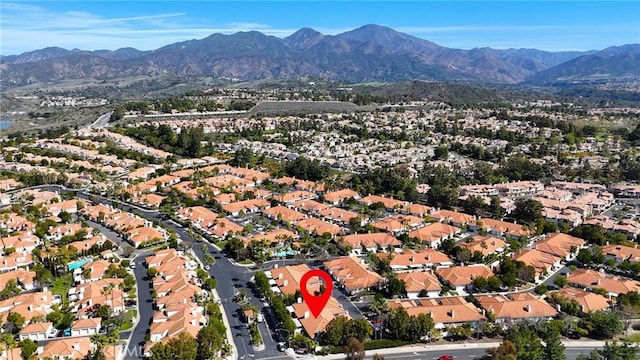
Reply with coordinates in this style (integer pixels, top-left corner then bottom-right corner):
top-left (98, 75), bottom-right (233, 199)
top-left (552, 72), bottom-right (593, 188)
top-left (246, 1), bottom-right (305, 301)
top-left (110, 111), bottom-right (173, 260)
top-left (0, 97), bottom-right (640, 360)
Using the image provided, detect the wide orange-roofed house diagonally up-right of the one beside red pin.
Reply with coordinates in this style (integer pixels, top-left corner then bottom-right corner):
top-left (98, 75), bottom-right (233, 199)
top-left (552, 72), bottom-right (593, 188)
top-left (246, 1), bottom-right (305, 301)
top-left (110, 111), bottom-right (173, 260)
top-left (378, 249), bottom-right (453, 272)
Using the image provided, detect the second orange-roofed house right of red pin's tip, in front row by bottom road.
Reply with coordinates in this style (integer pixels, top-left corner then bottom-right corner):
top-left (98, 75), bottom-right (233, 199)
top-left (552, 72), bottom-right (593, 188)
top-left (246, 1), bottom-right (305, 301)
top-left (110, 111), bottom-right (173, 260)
top-left (476, 293), bottom-right (558, 322)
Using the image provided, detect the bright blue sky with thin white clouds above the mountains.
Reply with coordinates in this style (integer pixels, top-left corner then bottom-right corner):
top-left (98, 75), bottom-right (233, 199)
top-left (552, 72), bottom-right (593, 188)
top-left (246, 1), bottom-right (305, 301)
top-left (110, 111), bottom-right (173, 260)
top-left (0, 0), bottom-right (640, 55)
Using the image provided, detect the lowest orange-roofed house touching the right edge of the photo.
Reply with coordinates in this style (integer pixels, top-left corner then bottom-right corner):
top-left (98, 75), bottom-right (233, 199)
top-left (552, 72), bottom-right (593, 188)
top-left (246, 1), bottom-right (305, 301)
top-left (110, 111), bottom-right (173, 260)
top-left (567, 269), bottom-right (640, 298)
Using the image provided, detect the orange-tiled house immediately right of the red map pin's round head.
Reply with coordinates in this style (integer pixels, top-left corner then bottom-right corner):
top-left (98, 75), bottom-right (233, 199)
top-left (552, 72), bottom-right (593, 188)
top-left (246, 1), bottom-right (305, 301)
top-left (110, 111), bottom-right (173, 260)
top-left (323, 256), bottom-right (386, 294)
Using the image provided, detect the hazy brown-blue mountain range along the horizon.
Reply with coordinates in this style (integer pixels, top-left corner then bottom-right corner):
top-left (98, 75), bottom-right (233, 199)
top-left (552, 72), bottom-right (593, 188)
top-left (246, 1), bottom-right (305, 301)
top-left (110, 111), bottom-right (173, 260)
top-left (0, 25), bottom-right (640, 87)
